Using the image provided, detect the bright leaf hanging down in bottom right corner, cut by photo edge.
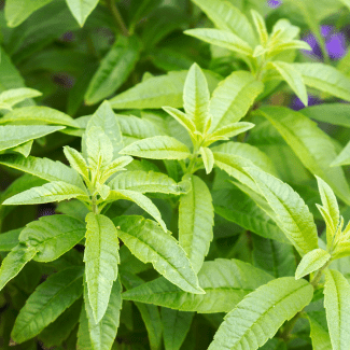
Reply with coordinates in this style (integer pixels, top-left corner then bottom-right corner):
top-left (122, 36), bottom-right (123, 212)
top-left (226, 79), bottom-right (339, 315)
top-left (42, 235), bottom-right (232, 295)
top-left (324, 270), bottom-right (350, 350)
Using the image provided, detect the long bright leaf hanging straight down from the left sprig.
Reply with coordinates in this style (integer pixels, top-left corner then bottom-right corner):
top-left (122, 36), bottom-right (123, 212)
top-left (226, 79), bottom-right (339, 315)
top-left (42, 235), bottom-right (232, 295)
top-left (84, 213), bottom-right (120, 323)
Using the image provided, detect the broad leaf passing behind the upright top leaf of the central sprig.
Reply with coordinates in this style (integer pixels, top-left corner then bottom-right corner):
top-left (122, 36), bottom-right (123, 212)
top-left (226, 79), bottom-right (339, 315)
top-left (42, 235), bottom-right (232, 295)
top-left (110, 71), bottom-right (220, 109)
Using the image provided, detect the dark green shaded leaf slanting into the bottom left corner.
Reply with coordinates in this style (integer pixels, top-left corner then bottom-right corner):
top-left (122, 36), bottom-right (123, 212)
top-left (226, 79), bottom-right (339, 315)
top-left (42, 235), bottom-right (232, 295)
top-left (12, 267), bottom-right (84, 344)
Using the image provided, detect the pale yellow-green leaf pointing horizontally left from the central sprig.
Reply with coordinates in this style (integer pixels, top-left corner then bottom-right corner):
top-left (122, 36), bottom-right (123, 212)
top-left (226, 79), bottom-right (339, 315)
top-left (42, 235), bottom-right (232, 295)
top-left (120, 136), bottom-right (191, 159)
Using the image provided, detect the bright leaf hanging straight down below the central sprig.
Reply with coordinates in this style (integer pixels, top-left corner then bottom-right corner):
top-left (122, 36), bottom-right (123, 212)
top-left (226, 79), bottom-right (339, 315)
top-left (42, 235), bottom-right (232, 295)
top-left (179, 175), bottom-right (214, 272)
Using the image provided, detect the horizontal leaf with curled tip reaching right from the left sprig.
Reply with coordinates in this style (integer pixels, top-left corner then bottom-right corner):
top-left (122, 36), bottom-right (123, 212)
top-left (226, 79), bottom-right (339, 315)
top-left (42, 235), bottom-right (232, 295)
top-left (108, 170), bottom-right (184, 194)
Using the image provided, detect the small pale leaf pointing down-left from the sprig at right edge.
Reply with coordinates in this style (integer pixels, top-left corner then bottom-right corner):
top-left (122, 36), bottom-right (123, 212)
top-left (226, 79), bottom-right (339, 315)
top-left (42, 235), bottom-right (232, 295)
top-left (295, 249), bottom-right (332, 280)
